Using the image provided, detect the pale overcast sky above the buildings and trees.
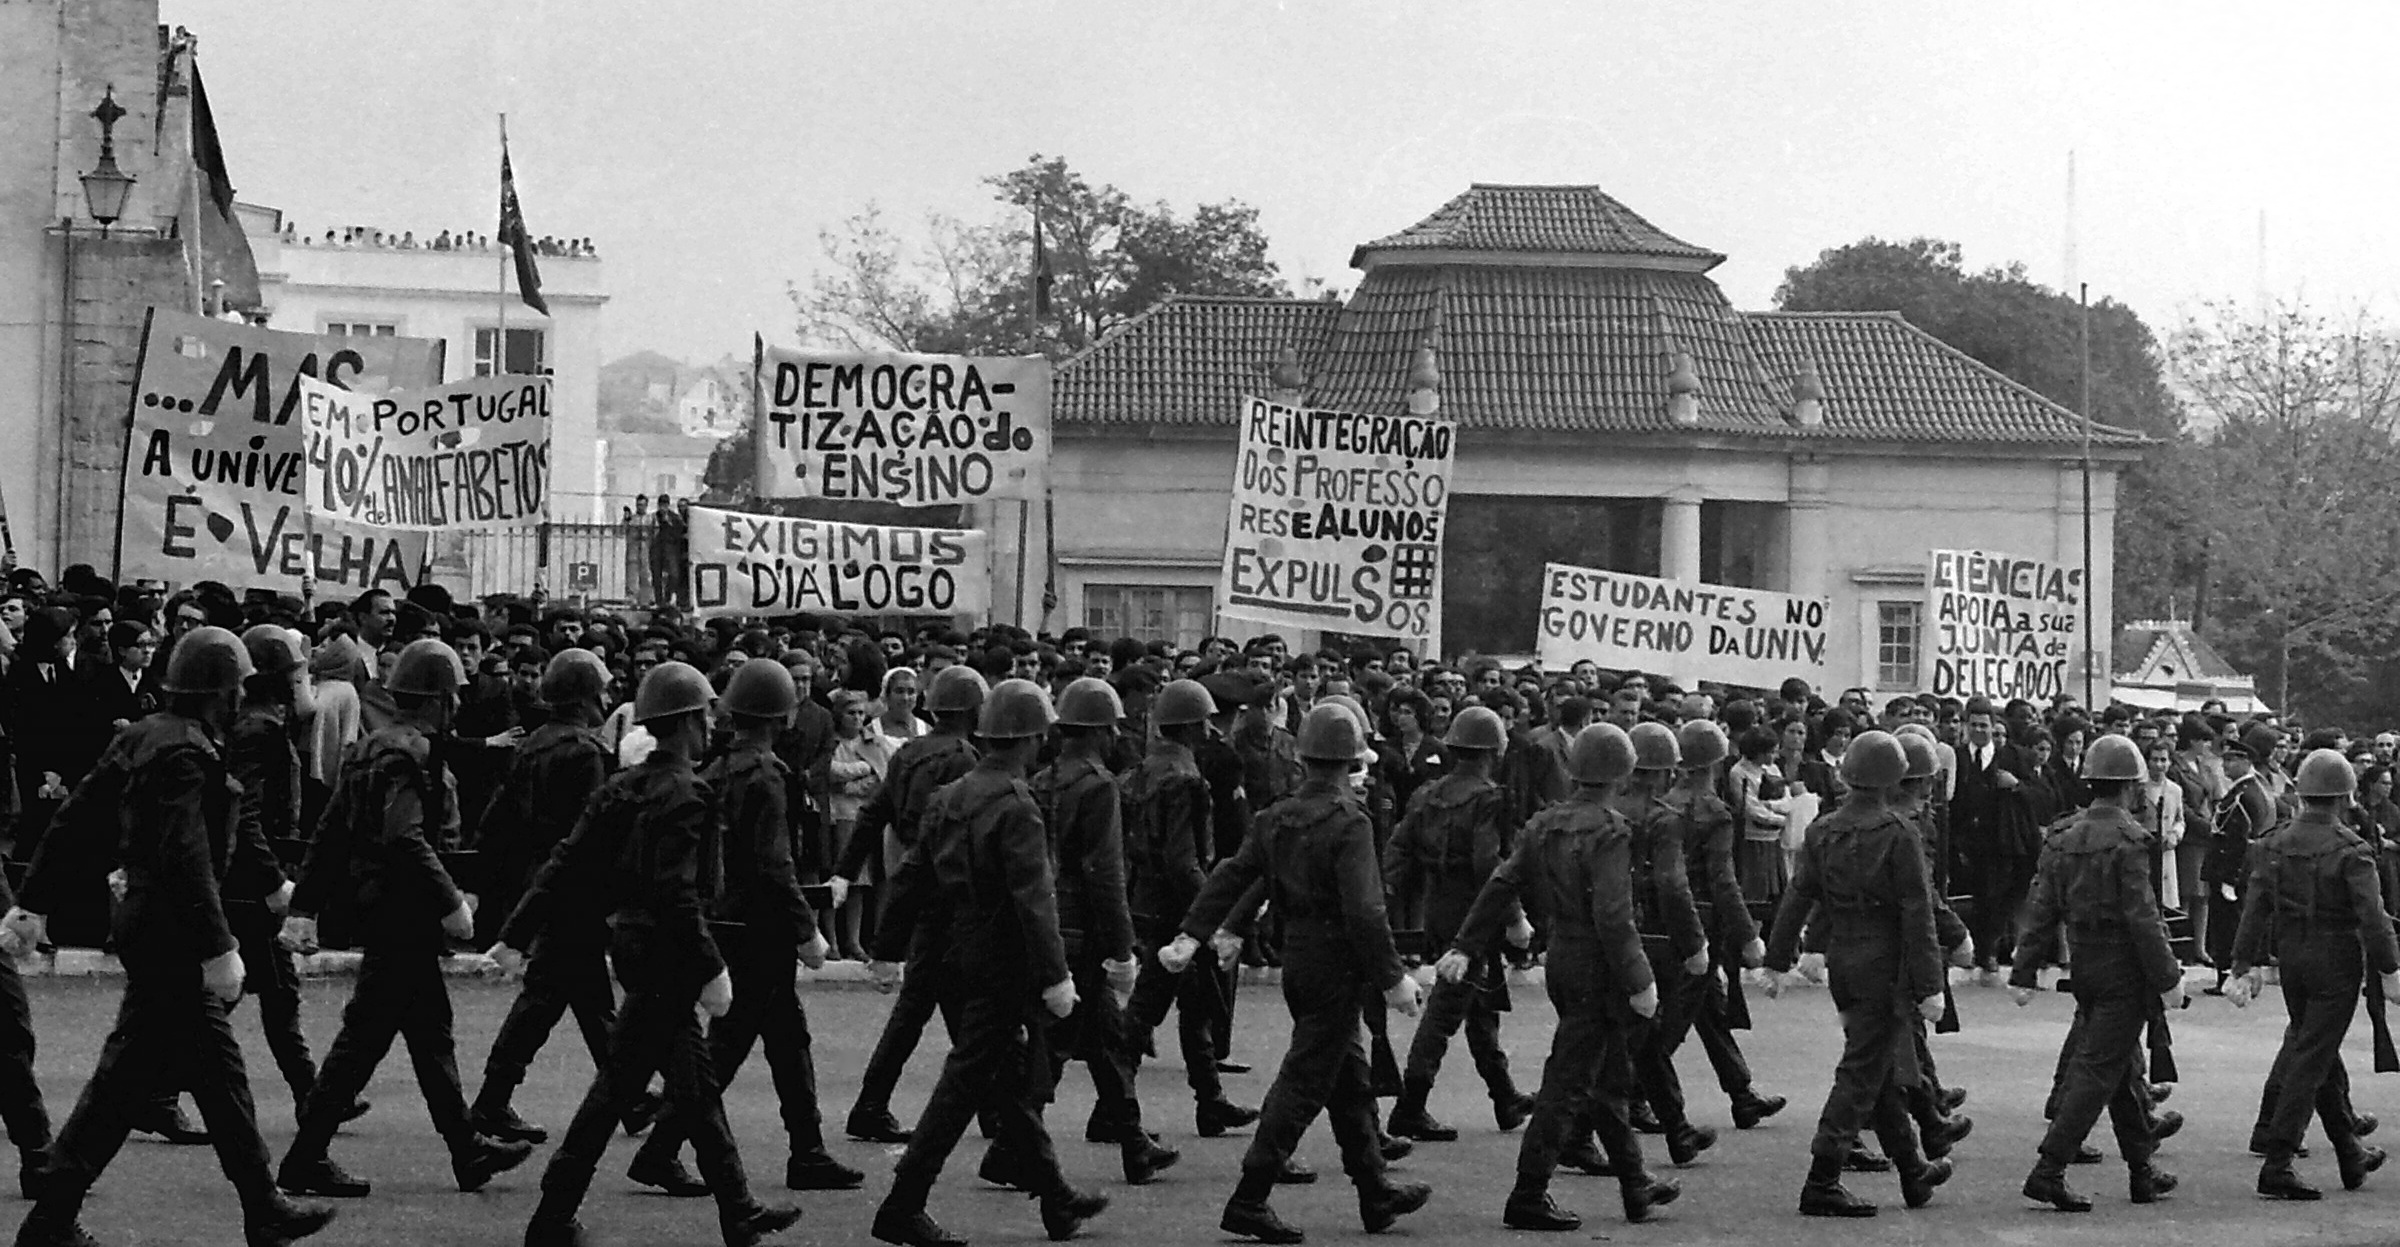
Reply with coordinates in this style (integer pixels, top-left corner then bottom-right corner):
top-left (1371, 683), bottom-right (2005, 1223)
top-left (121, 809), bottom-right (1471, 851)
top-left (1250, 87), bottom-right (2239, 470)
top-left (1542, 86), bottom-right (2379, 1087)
top-left (163, 0), bottom-right (2400, 360)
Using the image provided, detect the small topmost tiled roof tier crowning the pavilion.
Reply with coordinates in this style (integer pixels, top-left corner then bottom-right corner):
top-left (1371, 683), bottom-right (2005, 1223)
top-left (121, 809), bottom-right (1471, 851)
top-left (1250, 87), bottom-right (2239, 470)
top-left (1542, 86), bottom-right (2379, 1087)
top-left (1351, 182), bottom-right (1726, 269)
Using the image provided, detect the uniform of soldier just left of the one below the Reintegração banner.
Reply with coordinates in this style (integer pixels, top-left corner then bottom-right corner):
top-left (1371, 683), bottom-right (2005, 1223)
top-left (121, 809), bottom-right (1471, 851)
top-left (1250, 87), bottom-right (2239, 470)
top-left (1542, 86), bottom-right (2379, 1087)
top-left (1121, 736), bottom-right (1258, 1134)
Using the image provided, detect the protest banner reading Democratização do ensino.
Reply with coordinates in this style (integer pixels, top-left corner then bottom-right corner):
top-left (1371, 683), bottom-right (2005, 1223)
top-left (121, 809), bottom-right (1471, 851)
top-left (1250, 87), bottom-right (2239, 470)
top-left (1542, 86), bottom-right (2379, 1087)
top-left (751, 348), bottom-right (1051, 506)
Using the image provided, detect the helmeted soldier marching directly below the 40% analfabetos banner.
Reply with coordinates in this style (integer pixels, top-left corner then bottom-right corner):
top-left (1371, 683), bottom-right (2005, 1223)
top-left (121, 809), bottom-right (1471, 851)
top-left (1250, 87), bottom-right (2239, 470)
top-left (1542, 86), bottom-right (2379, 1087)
top-left (276, 638), bottom-right (533, 1199)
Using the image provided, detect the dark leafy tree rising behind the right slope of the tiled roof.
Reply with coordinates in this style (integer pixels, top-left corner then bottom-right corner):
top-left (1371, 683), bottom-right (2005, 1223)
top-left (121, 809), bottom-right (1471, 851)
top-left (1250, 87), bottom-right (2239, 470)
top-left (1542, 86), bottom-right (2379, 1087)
top-left (1776, 237), bottom-right (2206, 619)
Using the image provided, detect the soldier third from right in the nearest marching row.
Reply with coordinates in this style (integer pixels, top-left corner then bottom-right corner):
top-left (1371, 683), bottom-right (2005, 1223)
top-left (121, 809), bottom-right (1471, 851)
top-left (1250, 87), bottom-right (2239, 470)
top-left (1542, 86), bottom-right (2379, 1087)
top-left (1766, 731), bottom-right (1951, 1216)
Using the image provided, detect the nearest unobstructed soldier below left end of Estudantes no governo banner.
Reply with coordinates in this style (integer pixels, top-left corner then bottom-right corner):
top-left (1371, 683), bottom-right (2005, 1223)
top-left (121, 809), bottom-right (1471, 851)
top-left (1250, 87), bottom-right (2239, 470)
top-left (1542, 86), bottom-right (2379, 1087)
top-left (1435, 722), bottom-right (1682, 1233)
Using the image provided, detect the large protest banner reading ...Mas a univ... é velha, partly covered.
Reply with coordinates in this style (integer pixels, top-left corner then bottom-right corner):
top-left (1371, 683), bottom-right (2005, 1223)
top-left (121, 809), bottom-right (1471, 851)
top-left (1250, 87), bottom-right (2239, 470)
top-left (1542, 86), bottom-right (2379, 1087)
top-left (118, 307), bottom-right (442, 592)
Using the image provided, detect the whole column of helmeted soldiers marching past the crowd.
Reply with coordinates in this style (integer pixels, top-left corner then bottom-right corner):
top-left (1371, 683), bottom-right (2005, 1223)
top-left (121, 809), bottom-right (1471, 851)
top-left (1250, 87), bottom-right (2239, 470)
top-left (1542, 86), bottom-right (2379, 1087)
top-left (0, 628), bottom-right (2400, 1247)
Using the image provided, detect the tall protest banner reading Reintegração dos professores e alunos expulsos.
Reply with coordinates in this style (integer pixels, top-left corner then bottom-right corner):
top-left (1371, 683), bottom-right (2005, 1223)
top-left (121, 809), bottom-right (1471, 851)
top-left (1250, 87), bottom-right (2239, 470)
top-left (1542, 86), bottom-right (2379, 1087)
top-left (1217, 398), bottom-right (1457, 643)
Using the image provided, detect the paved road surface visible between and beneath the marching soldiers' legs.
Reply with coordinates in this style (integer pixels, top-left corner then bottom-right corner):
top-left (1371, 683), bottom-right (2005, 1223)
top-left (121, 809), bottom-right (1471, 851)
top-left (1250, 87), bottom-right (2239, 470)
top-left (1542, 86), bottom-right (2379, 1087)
top-left (0, 978), bottom-right (2400, 1247)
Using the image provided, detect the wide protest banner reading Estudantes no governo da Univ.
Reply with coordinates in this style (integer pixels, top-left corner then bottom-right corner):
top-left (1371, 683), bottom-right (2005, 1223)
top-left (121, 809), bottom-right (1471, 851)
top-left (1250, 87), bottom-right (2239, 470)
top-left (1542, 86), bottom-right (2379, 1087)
top-left (1536, 564), bottom-right (1829, 688)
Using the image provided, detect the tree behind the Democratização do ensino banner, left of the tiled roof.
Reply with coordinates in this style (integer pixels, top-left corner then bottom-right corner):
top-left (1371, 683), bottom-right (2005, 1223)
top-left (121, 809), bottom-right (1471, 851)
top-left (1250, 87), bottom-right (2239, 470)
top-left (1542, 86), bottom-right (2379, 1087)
top-left (790, 156), bottom-right (1291, 357)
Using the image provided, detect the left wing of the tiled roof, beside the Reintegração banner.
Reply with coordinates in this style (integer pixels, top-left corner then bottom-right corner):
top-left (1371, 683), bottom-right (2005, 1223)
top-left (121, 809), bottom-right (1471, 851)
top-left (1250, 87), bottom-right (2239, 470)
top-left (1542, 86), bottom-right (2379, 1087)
top-left (1051, 295), bottom-right (1342, 424)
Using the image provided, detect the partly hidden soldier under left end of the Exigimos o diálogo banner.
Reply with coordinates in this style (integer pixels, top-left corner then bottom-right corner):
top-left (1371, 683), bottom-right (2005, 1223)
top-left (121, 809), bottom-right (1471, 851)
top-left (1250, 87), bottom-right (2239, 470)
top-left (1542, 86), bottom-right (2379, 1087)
top-left (629, 659), bottom-right (866, 1194)
